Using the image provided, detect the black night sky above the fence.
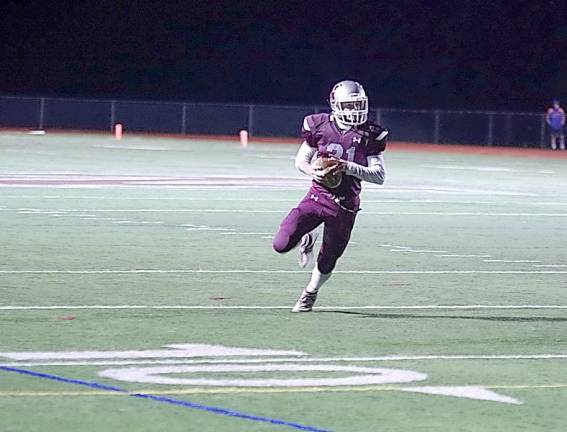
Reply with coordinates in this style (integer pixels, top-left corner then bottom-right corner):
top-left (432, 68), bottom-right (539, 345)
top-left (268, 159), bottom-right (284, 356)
top-left (0, 0), bottom-right (567, 111)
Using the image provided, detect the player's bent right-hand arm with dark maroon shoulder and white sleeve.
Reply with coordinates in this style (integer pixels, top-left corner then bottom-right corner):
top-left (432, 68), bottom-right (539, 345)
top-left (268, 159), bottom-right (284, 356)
top-left (343, 125), bottom-right (388, 184)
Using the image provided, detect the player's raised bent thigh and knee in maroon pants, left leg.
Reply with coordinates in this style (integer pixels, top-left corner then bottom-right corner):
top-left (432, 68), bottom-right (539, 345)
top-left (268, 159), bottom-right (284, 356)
top-left (272, 199), bottom-right (323, 253)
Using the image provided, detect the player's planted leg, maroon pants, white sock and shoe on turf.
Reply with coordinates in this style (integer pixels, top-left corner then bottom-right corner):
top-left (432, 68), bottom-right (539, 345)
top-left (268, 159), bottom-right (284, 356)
top-left (292, 210), bottom-right (356, 312)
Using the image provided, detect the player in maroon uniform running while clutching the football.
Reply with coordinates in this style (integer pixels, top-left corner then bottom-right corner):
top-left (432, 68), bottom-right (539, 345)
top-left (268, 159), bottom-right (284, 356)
top-left (273, 80), bottom-right (388, 312)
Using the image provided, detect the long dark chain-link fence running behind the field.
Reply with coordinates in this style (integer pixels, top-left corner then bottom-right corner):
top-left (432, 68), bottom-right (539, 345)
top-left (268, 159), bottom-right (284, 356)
top-left (0, 96), bottom-right (547, 148)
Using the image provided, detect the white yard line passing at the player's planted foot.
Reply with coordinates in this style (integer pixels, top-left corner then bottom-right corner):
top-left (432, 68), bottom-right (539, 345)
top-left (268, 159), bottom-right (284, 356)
top-left (0, 304), bottom-right (567, 311)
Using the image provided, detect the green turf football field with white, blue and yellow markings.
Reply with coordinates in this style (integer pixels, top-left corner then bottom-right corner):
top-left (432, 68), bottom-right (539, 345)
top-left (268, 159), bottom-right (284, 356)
top-left (0, 133), bottom-right (567, 432)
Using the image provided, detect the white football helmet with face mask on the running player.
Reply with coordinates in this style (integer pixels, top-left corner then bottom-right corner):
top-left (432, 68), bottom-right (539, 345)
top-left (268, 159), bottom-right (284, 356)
top-left (329, 80), bottom-right (368, 126)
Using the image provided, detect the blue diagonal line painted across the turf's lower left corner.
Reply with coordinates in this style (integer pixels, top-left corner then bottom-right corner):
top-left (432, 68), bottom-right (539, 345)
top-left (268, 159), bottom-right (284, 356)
top-left (0, 365), bottom-right (331, 432)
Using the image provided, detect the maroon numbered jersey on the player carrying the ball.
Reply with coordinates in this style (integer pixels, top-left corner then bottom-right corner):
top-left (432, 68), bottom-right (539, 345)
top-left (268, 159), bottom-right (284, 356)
top-left (301, 114), bottom-right (387, 204)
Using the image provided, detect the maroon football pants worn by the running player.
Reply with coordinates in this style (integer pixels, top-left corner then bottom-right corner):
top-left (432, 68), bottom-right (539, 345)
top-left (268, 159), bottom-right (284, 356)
top-left (273, 191), bottom-right (356, 274)
